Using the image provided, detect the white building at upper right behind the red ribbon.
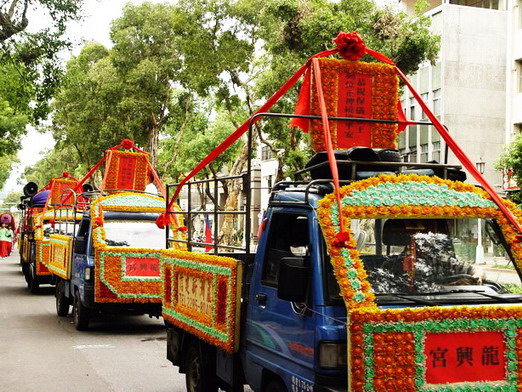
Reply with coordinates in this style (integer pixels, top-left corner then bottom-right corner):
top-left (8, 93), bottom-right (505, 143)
top-left (399, 0), bottom-right (522, 191)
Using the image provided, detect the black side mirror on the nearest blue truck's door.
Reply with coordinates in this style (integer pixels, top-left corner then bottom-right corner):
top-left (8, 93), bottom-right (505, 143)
top-left (277, 257), bottom-right (310, 302)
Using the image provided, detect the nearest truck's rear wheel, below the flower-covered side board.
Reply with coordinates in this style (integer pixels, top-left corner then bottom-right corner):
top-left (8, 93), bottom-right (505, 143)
top-left (185, 345), bottom-right (217, 392)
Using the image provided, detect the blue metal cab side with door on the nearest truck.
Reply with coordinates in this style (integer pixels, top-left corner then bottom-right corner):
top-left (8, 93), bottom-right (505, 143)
top-left (245, 186), bottom-right (347, 391)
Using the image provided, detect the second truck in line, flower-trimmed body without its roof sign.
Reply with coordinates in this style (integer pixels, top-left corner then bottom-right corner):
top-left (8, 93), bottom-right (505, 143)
top-left (49, 192), bottom-right (164, 330)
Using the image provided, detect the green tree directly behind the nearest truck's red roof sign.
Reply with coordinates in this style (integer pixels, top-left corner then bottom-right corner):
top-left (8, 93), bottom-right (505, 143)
top-left (256, 0), bottom-right (439, 180)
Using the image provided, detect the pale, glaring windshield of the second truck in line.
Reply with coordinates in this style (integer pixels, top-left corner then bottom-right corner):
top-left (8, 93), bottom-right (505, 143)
top-left (104, 220), bottom-right (165, 249)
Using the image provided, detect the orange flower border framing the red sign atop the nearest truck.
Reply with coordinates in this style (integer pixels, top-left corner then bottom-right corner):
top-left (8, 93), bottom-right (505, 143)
top-left (310, 58), bottom-right (399, 152)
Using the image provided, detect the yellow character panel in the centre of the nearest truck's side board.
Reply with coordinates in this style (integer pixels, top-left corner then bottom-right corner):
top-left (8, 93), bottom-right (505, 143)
top-left (177, 273), bottom-right (213, 321)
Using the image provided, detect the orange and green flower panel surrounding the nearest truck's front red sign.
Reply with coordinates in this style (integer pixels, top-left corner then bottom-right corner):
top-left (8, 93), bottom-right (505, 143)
top-left (349, 306), bottom-right (522, 392)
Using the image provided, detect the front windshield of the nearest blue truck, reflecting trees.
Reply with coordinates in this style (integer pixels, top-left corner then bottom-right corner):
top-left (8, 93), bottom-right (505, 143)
top-left (322, 219), bottom-right (522, 296)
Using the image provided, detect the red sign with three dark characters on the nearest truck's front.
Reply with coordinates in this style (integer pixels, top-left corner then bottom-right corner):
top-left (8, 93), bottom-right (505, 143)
top-left (424, 332), bottom-right (506, 384)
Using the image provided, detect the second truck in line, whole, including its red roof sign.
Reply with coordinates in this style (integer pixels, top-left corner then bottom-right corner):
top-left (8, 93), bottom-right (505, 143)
top-left (46, 141), bottom-right (171, 330)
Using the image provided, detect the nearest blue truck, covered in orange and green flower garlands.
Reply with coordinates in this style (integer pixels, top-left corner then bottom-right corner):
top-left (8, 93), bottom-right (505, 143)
top-left (158, 34), bottom-right (522, 392)
